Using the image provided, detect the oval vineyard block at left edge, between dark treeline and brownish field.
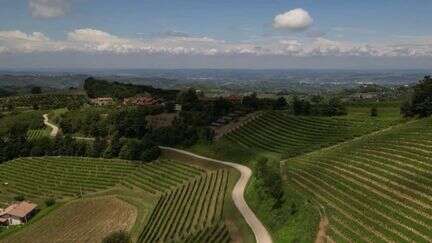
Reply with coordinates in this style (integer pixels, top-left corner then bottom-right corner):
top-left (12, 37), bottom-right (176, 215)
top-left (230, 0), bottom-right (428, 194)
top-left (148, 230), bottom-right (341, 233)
top-left (0, 157), bottom-right (135, 198)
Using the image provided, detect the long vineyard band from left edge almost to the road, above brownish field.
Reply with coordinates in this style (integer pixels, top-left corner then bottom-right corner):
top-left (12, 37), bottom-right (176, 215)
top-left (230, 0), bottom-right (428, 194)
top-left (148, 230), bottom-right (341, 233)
top-left (0, 157), bottom-right (203, 198)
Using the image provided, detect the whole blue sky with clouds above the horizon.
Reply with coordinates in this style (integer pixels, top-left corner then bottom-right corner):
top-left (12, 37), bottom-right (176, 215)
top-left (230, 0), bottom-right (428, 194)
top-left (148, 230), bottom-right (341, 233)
top-left (0, 0), bottom-right (432, 69)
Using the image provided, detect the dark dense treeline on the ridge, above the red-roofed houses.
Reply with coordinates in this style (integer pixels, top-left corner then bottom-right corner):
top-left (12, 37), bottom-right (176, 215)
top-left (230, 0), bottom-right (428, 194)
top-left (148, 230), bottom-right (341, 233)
top-left (84, 77), bottom-right (178, 100)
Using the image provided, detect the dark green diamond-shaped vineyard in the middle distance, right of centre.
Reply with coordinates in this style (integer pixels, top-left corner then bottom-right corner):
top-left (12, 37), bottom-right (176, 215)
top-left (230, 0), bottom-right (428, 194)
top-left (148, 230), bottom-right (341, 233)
top-left (225, 111), bottom-right (402, 157)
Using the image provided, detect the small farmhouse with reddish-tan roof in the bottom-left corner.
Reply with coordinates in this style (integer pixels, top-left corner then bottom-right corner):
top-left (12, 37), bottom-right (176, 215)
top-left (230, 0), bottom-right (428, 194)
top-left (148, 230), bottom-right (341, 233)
top-left (0, 201), bottom-right (37, 225)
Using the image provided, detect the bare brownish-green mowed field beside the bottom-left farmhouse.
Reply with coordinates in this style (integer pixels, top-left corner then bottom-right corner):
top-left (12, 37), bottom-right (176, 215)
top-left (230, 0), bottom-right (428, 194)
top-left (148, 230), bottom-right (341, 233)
top-left (2, 196), bottom-right (137, 243)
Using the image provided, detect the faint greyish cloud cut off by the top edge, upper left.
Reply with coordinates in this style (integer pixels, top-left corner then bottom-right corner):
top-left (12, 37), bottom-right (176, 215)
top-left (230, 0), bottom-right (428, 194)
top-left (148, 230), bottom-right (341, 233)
top-left (29, 0), bottom-right (70, 18)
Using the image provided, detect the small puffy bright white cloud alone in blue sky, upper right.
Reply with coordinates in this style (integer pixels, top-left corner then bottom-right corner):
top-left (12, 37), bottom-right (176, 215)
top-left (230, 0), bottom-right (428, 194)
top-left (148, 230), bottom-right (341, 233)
top-left (273, 8), bottom-right (313, 30)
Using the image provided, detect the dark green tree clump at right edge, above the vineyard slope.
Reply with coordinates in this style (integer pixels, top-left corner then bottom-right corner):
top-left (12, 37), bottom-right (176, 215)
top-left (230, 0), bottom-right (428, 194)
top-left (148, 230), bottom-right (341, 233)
top-left (401, 76), bottom-right (432, 117)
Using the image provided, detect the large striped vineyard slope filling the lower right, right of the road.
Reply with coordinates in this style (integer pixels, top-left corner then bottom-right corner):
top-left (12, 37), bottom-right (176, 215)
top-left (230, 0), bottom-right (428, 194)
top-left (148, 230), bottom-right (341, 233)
top-left (286, 119), bottom-right (432, 242)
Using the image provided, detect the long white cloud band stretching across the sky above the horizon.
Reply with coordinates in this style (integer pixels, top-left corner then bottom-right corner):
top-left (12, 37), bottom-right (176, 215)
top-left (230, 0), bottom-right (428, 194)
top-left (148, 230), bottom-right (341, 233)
top-left (0, 28), bottom-right (432, 57)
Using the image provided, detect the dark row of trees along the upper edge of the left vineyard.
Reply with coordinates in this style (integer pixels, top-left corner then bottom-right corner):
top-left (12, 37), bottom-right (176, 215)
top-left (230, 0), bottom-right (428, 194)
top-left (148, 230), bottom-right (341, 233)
top-left (0, 124), bottom-right (160, 163)
